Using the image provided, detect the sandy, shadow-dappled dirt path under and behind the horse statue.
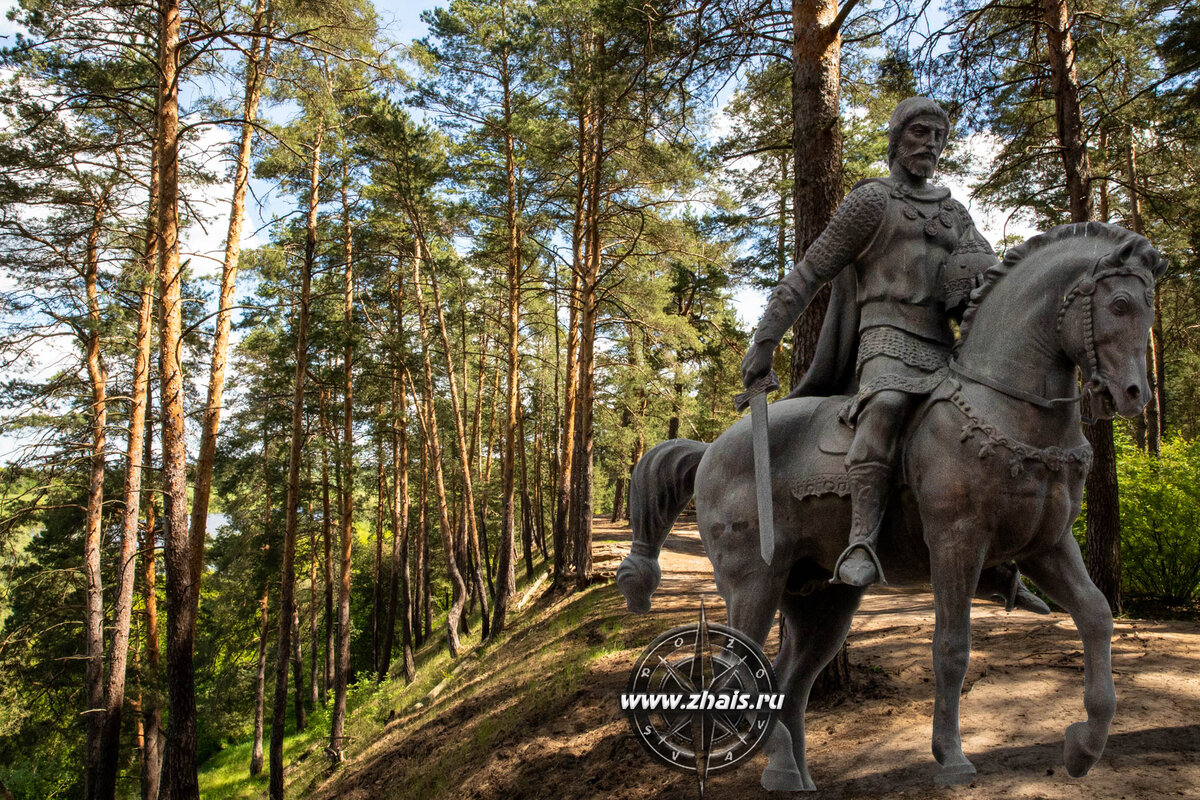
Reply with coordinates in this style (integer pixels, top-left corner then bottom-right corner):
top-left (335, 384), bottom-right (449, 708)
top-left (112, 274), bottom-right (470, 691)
top-left (594, 521), bottom-right (1200, 800)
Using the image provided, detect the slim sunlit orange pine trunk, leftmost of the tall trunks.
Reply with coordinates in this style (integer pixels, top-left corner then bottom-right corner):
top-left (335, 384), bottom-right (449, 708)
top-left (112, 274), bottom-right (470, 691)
top-left (83, 200), bottom-right (109, 798)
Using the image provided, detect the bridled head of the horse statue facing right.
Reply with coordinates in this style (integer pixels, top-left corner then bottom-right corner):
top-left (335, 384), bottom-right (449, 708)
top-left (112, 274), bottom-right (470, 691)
top-left (1058, 231), bottom-right (1166, 419)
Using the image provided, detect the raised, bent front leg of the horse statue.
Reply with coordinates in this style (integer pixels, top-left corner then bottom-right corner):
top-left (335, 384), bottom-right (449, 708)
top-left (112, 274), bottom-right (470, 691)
top-left (1020, 533), bottom-right (1117, 777)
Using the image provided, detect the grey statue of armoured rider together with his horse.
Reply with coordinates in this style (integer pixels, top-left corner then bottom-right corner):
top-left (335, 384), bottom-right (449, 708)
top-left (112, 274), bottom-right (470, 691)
top-left (617, 98), bottom-right (1165, 790)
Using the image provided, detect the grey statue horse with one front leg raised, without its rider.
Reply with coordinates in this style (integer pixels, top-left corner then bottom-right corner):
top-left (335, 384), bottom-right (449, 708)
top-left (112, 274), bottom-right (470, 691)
top-left (617, 222), bottom-right (1166, 790)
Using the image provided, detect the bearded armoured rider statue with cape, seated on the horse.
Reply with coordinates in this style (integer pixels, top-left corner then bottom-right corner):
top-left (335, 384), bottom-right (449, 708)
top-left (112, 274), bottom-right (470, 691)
top-left (742, 97), bottom-right (1003, 593)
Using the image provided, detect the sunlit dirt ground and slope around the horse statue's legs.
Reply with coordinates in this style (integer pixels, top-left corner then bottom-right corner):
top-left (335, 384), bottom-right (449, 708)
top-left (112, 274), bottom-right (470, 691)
top-left (304, 521), bottom-right (1200, 800)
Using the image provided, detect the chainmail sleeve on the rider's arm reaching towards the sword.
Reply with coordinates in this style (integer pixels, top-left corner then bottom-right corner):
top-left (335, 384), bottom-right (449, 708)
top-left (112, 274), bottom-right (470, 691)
top-left (754, 181), bottom-right (888, 343)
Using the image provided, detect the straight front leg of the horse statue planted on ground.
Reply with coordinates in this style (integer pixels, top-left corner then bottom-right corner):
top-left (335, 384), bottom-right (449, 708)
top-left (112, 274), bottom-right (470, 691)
top-left (926, 521), bottom-right (983, 784)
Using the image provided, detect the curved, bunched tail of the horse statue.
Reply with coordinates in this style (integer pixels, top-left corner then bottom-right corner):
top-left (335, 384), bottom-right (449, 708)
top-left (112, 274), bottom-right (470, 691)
top-left (617, 439), bottom-right (708, 614)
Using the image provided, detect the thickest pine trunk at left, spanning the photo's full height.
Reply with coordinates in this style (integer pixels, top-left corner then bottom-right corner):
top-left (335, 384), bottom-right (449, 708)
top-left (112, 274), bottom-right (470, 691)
top-left (157, 0), bottom-right (199, 800)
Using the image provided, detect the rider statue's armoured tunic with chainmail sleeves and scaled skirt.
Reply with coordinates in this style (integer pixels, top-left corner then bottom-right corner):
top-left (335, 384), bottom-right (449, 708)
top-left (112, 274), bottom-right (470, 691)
top-left (755, 178), bottom-right (996, 423)
